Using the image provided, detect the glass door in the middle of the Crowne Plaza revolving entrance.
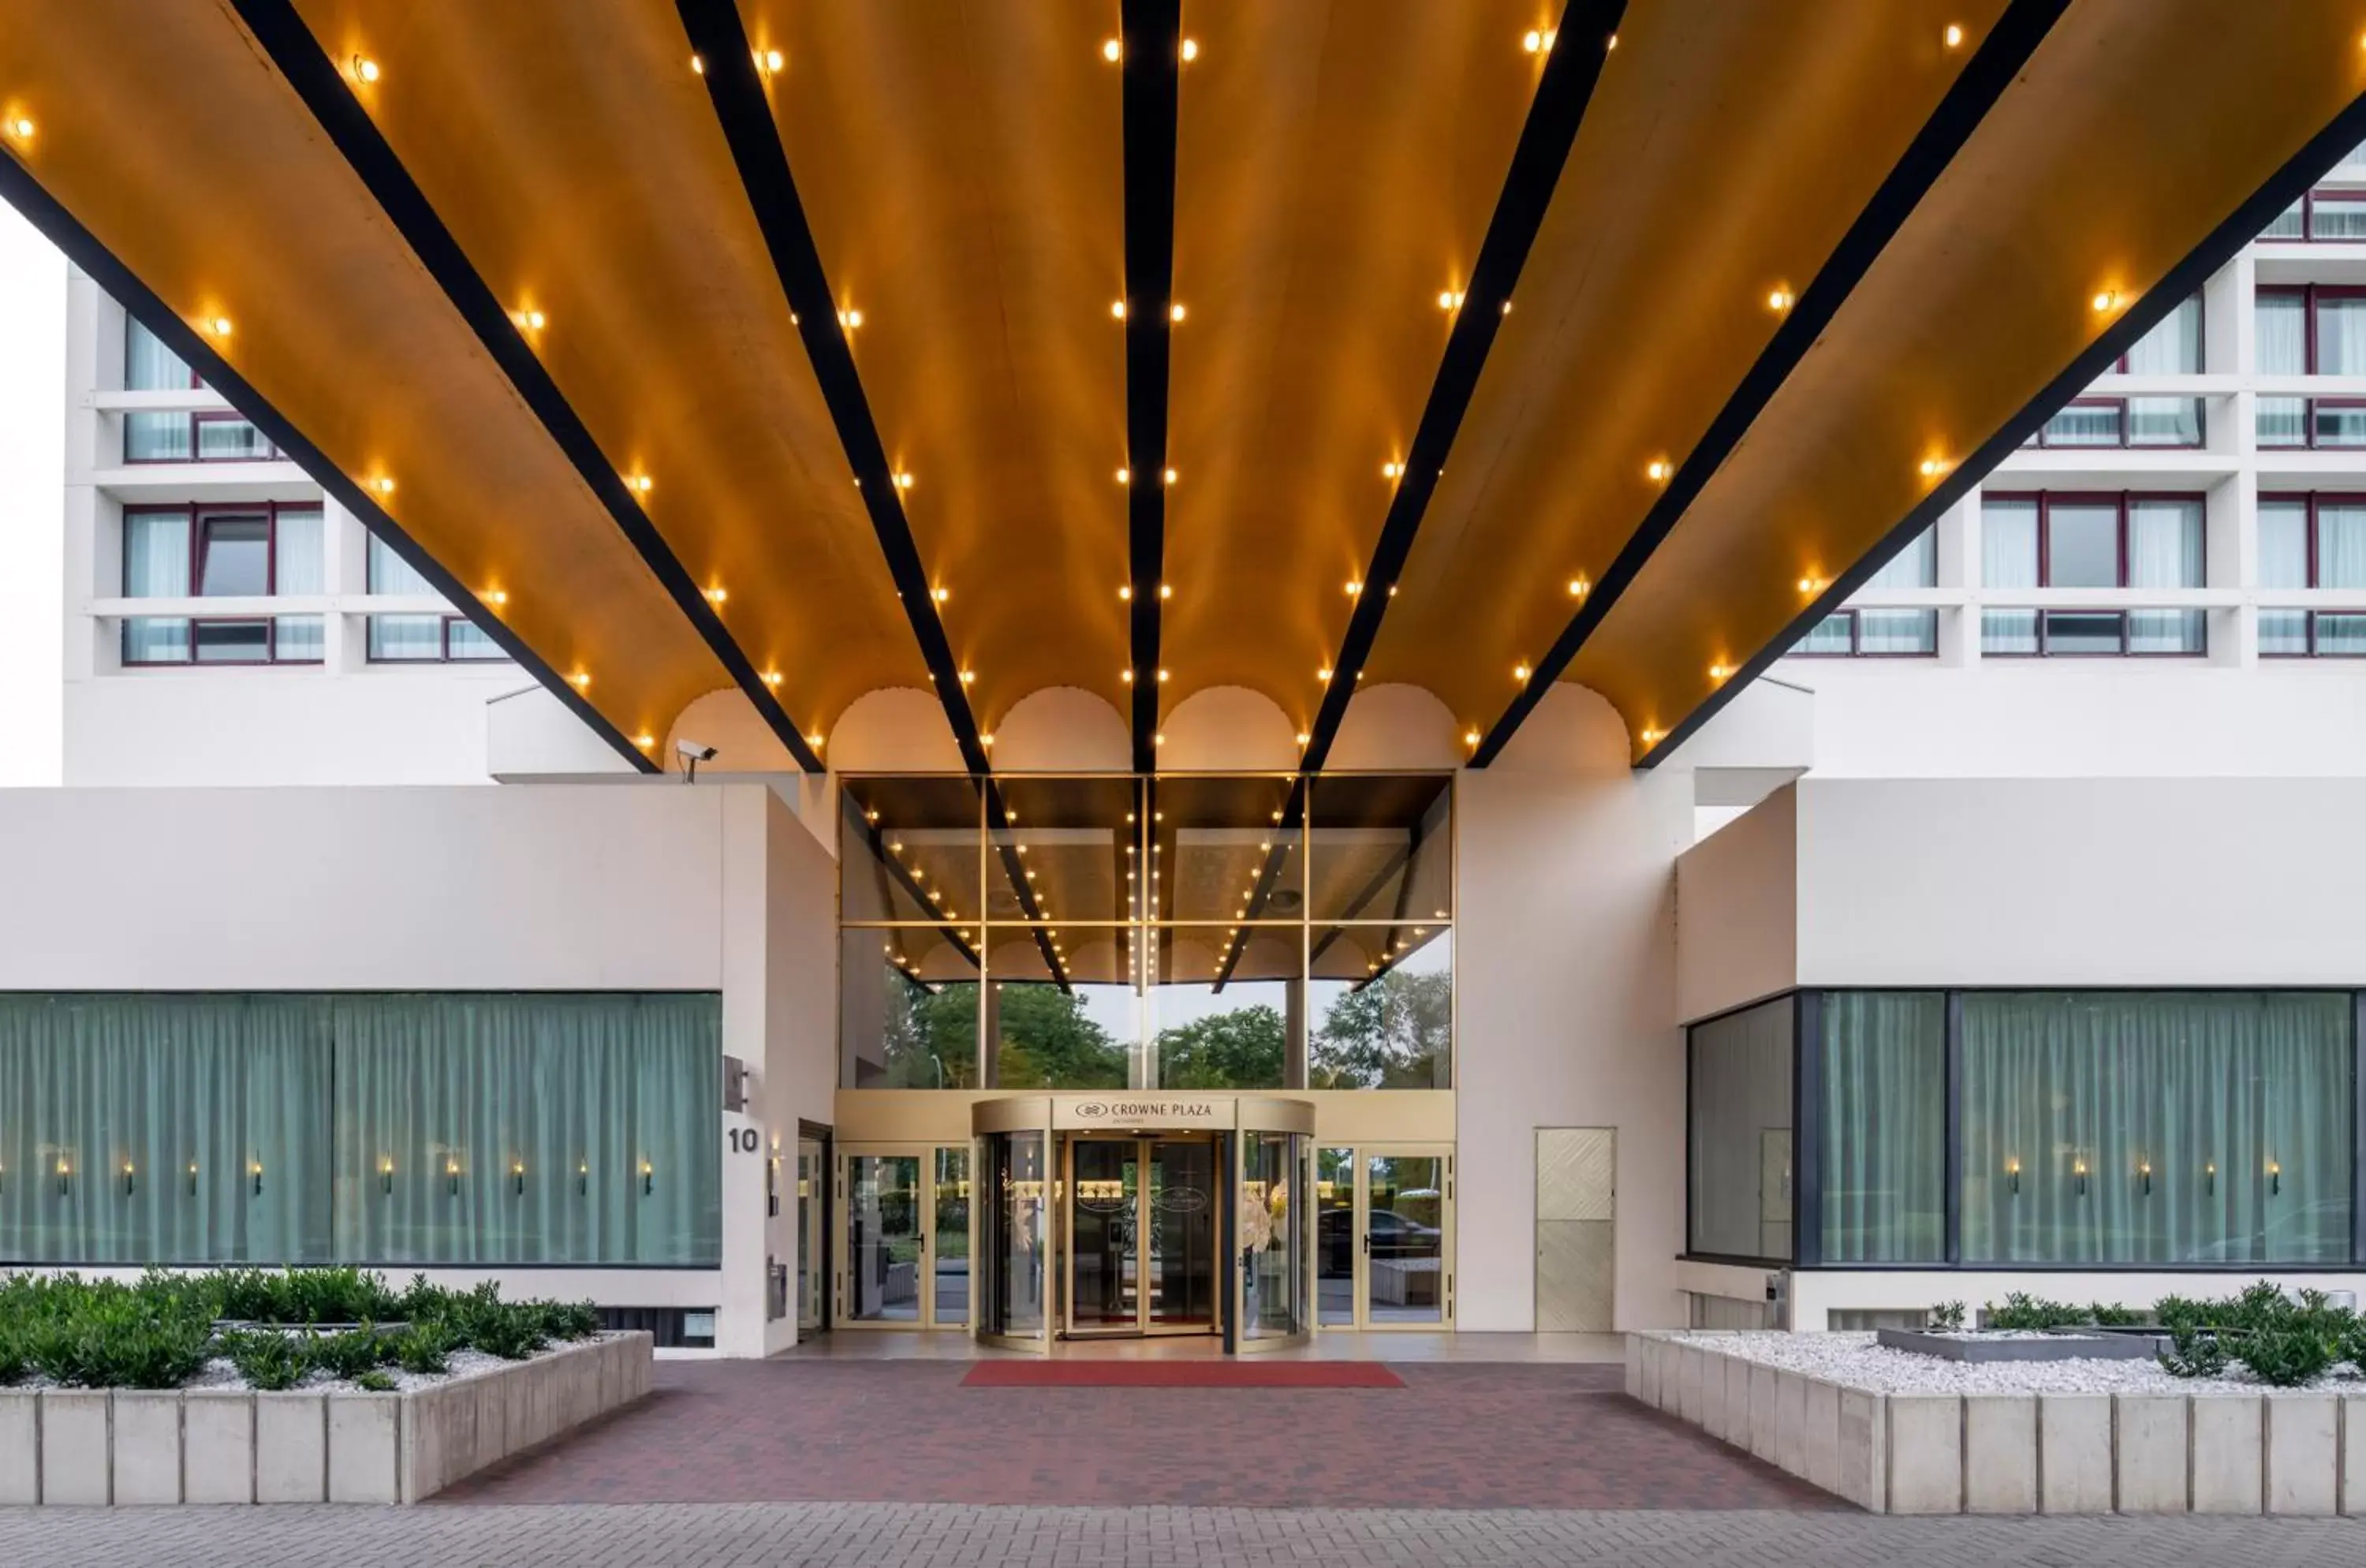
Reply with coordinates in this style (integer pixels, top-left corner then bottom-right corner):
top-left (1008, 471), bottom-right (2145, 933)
top-left (1067, 1137), bottom-right (1221, 1334)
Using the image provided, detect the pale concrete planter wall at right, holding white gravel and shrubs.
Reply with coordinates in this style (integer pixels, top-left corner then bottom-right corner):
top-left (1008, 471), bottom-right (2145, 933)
top-left (1637, 1331), bottom-right (2366, 1516)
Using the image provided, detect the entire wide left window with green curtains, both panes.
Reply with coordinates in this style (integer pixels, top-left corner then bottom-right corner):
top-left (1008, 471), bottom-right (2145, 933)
top-left (0, 993), bottom-right (722, 1265)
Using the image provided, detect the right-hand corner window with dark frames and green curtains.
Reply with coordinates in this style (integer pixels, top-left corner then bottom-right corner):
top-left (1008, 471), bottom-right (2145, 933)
top-left (1689, 991), bottom-right (2359, 1270)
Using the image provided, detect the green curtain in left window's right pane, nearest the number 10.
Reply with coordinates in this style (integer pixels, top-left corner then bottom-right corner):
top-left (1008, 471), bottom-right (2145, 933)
top-left (336, 995), bottom-right (722, 1265)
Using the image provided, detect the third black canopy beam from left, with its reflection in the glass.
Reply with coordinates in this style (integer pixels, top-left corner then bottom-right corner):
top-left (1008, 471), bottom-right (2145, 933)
top-left (677, 0), bottom-right (1067, 988)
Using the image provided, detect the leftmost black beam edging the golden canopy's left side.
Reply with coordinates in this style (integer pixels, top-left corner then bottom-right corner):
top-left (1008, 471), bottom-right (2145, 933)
top-left (0, 127), bottom-right (665, 774)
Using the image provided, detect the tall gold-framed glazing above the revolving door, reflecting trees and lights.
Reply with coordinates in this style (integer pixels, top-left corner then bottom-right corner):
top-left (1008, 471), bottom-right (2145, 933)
top-left (840, 774), bottom-right (1453, 1090)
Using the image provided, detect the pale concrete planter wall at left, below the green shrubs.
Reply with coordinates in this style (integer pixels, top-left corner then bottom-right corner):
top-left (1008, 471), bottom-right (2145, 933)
top-left (0, 1334), bottom-right (648, 1506)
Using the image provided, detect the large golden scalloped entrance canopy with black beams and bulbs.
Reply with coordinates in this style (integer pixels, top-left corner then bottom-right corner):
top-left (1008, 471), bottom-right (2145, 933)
top-left (0, 0), bottom-right (2366, 774)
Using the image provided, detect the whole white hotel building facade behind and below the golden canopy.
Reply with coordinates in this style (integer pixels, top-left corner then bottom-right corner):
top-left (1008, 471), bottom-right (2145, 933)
top-left (0, 163), bottom-right (2366, 1355)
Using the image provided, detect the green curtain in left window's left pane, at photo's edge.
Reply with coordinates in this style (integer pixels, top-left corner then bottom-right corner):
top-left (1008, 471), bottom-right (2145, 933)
top-left (0, 993), bottom-right (331, 1263)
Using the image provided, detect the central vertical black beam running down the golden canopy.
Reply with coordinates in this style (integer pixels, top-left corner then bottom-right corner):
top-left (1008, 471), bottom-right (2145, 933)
top-left (1119, 0), bottom-right (1183, 774)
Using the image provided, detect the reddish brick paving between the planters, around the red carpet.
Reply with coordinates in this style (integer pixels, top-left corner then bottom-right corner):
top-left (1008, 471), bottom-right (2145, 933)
top-left (435, 1357), bottom-right (1845, 1509)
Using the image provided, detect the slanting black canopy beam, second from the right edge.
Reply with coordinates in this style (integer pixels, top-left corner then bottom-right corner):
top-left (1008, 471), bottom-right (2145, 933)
top-left (1469, 0), bottom-right (2070, 769)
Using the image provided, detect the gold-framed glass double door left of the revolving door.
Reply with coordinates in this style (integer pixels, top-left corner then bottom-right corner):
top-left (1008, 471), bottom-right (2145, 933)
top-left (838, 1144), bottom-right (970, 1329)
